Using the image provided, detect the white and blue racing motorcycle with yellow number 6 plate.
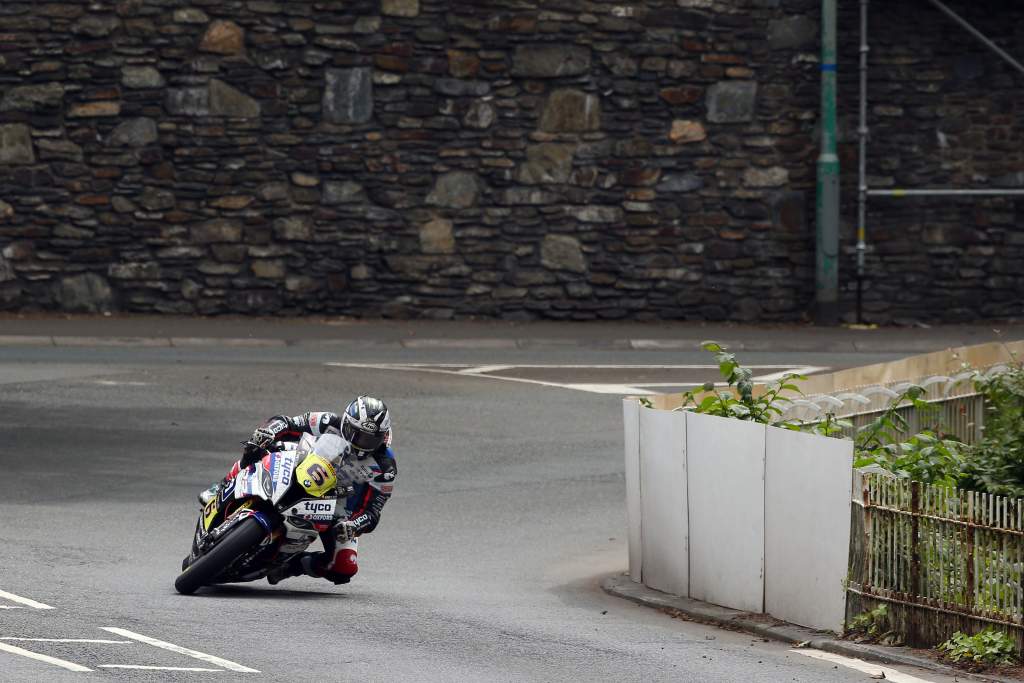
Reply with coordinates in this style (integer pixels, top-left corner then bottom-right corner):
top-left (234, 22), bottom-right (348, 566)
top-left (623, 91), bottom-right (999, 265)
top-left (174, 434), bottom-right (374, 595)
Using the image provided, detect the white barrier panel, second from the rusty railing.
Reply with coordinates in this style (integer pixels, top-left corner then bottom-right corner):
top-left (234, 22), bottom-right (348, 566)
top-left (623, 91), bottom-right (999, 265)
top-left (686, 413), bottom-right (765, 612)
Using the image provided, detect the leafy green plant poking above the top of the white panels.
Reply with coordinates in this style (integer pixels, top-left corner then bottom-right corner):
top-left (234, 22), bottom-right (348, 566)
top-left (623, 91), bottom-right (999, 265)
top-left (681, 341), bottom-right (807, 429)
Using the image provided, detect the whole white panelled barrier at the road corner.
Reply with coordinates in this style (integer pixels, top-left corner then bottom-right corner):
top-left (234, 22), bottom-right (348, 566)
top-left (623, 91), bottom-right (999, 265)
top-left (623, 399), bottom-right (853, 631)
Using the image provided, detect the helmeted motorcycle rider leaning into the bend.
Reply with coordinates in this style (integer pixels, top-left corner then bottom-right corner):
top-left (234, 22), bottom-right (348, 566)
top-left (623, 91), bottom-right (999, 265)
top-left (199, 396), bottom-right (398, 585)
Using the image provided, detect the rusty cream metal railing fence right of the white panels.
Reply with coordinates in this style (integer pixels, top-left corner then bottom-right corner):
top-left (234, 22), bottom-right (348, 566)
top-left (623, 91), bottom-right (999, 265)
top-left (847, 473), bottom-right (1024, 649)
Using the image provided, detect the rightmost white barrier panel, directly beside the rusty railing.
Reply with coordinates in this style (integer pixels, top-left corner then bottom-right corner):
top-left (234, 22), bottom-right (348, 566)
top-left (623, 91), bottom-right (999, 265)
top-left (765, 427), bottom-right (853, 632)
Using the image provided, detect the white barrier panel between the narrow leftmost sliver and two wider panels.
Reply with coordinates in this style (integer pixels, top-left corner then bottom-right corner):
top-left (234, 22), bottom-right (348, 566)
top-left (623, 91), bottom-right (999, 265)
top-left (639, 408), bottom-right (689, 596)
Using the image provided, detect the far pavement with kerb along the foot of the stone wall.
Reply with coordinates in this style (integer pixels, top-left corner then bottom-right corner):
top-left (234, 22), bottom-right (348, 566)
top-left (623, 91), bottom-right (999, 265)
top-left (0, 314), bottom-right (1024, 353)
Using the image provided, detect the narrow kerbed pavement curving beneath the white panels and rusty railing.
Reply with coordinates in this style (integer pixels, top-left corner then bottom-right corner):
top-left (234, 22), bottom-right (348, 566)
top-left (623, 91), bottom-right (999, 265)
top-left (601, 574), bottom-right (1020, 683)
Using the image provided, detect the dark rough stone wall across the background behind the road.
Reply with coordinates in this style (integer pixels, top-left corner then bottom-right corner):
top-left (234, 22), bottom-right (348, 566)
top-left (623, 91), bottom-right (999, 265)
top-left (0, 0), bottom-right (1024, 322)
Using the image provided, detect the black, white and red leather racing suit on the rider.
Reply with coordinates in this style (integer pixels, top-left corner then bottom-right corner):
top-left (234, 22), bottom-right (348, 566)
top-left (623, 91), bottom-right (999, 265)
top-left (226, 413), bottom-right (398, 584)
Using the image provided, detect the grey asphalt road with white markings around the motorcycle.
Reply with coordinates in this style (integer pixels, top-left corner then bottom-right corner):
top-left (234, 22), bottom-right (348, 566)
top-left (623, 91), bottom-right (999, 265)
top-left (0, 337), bottom-right (966, 682)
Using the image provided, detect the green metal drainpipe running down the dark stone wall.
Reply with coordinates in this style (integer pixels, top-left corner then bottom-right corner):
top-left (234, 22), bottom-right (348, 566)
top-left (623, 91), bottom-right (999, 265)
top-left (814, 0), bottom-right (840, 325)
